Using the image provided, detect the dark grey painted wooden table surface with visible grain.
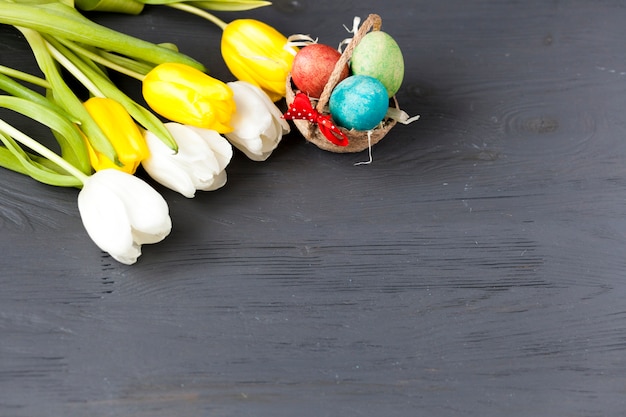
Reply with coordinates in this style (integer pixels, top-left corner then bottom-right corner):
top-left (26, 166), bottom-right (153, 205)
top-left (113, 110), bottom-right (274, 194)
top-left (0, 0), bottom-right (626, 417)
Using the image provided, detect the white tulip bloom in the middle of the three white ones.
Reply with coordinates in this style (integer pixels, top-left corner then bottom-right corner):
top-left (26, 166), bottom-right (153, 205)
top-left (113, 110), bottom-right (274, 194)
top-left (142, 122), bottom-right (233, 198)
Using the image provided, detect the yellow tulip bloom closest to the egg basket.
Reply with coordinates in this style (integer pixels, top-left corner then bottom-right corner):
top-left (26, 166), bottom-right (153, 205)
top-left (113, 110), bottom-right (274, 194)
top-left (222, 19), bottom-right (297, 101)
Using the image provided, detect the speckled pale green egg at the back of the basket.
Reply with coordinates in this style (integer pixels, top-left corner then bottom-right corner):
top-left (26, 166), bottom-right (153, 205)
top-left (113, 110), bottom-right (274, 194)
top-left (350, 31), bottom-right (404, 97)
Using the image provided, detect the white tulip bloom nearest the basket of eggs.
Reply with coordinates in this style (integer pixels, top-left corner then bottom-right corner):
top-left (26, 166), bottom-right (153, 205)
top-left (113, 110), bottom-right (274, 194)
top-left (225, 81), bottom-right (290, 161)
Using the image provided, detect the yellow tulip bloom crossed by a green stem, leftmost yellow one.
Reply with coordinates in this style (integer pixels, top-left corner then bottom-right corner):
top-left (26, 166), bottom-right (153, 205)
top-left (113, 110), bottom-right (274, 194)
top-left (84, 97), bottom-right (150, 174)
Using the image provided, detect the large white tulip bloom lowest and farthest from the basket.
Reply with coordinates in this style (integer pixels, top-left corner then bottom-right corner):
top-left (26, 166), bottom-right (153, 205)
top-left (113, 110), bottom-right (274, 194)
top-left (78, 169), bottom-right (172, 265)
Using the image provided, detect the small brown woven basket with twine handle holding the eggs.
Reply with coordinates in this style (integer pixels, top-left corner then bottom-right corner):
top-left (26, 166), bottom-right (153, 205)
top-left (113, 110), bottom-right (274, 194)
top-left (285, 14), bottom-right (399, 153)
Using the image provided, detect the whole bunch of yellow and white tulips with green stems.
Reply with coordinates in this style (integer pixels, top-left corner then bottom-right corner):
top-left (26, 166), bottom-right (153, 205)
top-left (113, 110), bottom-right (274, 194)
top-left (0, 0), bottom-right (296, 264)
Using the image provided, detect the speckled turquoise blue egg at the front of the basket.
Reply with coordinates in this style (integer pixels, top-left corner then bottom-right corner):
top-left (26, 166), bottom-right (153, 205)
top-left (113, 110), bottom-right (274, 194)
top-left (328, 75), bottom-right (389, 130)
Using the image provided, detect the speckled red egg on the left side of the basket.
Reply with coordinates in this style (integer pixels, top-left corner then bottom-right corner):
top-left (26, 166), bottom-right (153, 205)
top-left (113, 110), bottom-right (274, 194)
top-left (291, 43), bottom-right (350, 98)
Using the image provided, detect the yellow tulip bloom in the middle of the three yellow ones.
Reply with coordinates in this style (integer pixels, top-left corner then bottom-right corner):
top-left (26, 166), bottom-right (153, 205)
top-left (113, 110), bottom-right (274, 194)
top-left (142, 63), bottom-right (235, 133)
